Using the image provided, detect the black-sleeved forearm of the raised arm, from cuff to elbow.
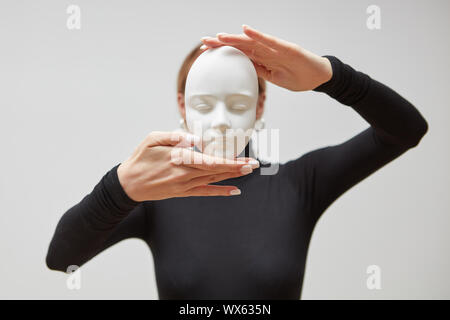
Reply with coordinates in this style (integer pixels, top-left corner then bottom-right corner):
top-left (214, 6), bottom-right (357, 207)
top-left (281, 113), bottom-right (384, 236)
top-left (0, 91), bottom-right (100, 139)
top-left (314, 56), bottom-right (428, 148)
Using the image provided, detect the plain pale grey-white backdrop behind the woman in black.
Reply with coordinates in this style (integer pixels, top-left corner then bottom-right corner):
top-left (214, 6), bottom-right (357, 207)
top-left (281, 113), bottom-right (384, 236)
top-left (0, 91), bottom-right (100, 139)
top-left (0, 0), bottom-right (450, 299)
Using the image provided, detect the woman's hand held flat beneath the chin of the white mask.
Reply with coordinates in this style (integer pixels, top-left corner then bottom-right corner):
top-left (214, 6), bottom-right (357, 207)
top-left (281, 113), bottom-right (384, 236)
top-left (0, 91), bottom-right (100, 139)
top-left (117, 131), bottom-right (259, 202)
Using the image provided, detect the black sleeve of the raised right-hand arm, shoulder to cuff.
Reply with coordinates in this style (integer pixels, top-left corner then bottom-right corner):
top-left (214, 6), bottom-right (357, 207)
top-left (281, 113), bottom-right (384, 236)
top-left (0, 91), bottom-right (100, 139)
top-left (303, 56), bottom-right (428, 219)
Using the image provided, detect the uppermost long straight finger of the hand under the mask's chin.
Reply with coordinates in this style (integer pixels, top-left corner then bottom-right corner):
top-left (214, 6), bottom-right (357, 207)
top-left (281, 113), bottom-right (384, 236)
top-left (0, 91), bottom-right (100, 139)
top-left (171, 148), bottom-right (259, 172)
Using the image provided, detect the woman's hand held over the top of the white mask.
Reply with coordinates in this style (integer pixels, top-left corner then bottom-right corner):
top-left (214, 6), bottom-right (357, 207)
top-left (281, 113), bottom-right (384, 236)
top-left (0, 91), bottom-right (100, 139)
top-left (201, 25), bottom-right (333, 91)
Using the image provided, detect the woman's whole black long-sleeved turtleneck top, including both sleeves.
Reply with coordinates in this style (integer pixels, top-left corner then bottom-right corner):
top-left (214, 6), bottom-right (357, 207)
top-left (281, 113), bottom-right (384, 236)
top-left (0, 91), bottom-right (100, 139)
top-left (46, 56), bottom-right (427, 299)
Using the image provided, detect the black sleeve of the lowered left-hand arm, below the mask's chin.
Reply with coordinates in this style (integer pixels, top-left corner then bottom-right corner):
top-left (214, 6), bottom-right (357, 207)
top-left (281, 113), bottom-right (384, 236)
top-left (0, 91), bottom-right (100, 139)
top-left (46, 166), bottom-right (146, 272)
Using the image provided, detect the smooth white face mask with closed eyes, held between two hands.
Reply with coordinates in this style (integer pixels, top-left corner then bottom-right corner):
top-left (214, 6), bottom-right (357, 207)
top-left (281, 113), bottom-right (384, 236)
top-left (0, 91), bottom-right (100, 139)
top-left (185, 46), bottom-right (258, 159)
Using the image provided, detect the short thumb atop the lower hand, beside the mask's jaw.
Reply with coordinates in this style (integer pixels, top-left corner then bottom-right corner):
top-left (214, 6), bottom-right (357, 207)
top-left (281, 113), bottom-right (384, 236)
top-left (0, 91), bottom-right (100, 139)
top-left (144, 131), bottom-right (202, 149)
